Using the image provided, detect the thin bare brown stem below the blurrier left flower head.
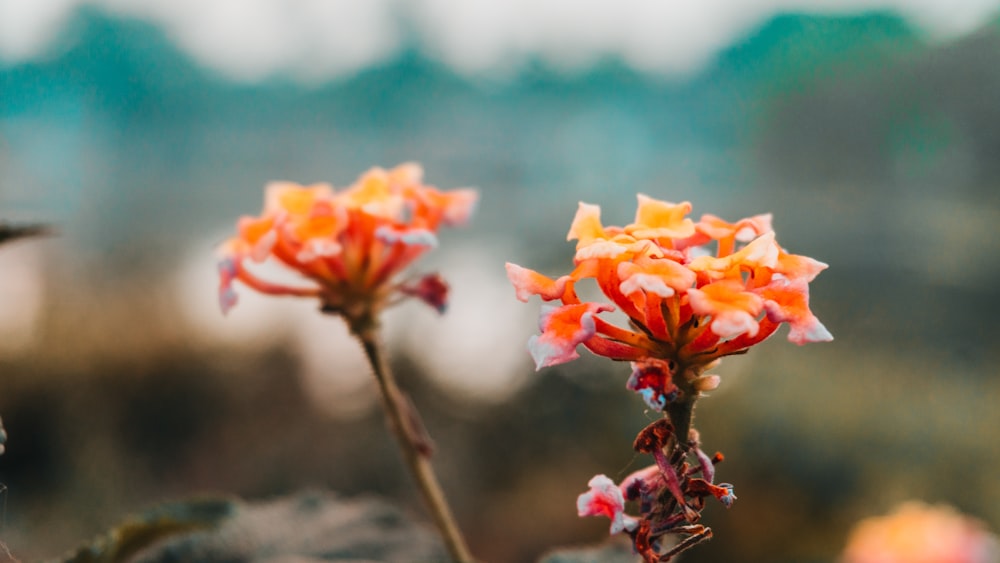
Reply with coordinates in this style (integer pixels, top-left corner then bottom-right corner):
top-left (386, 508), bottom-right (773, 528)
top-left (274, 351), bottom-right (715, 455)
top-left (354, 326), bottom-right (475, 563)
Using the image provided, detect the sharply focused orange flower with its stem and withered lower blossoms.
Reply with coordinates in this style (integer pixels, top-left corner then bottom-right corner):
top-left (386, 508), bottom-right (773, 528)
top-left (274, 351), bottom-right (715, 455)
top-left (507, 195), bottom-right (833, 563)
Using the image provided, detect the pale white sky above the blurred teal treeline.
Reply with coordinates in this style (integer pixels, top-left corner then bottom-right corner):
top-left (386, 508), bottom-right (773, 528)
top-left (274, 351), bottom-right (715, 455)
top-left (0, 0), bottom-right (1000, 81)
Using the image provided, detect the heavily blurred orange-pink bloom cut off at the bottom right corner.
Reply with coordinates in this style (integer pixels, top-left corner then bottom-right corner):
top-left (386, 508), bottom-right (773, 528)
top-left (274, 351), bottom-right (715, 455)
top-left (841, 501), bottom-right (1000, 563)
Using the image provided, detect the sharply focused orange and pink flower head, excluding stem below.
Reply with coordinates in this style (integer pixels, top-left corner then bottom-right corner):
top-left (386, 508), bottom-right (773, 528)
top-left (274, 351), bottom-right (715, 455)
top-left (507, 194), bottom-right (833, 410)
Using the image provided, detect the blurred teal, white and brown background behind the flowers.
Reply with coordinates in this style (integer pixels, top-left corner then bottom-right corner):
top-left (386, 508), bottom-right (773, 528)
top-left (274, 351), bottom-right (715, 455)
top-left (0, 0), bottom-right (1000, 562)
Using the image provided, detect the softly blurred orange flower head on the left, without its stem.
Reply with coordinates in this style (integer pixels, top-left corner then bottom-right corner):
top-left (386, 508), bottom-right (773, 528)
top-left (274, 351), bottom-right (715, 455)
top-left (219, 163), bottom-right (476, 321)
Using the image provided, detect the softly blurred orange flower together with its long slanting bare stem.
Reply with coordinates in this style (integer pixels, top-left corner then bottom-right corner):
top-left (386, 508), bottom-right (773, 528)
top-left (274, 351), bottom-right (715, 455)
top-left (219, 163), bottom-right (476, 563)
